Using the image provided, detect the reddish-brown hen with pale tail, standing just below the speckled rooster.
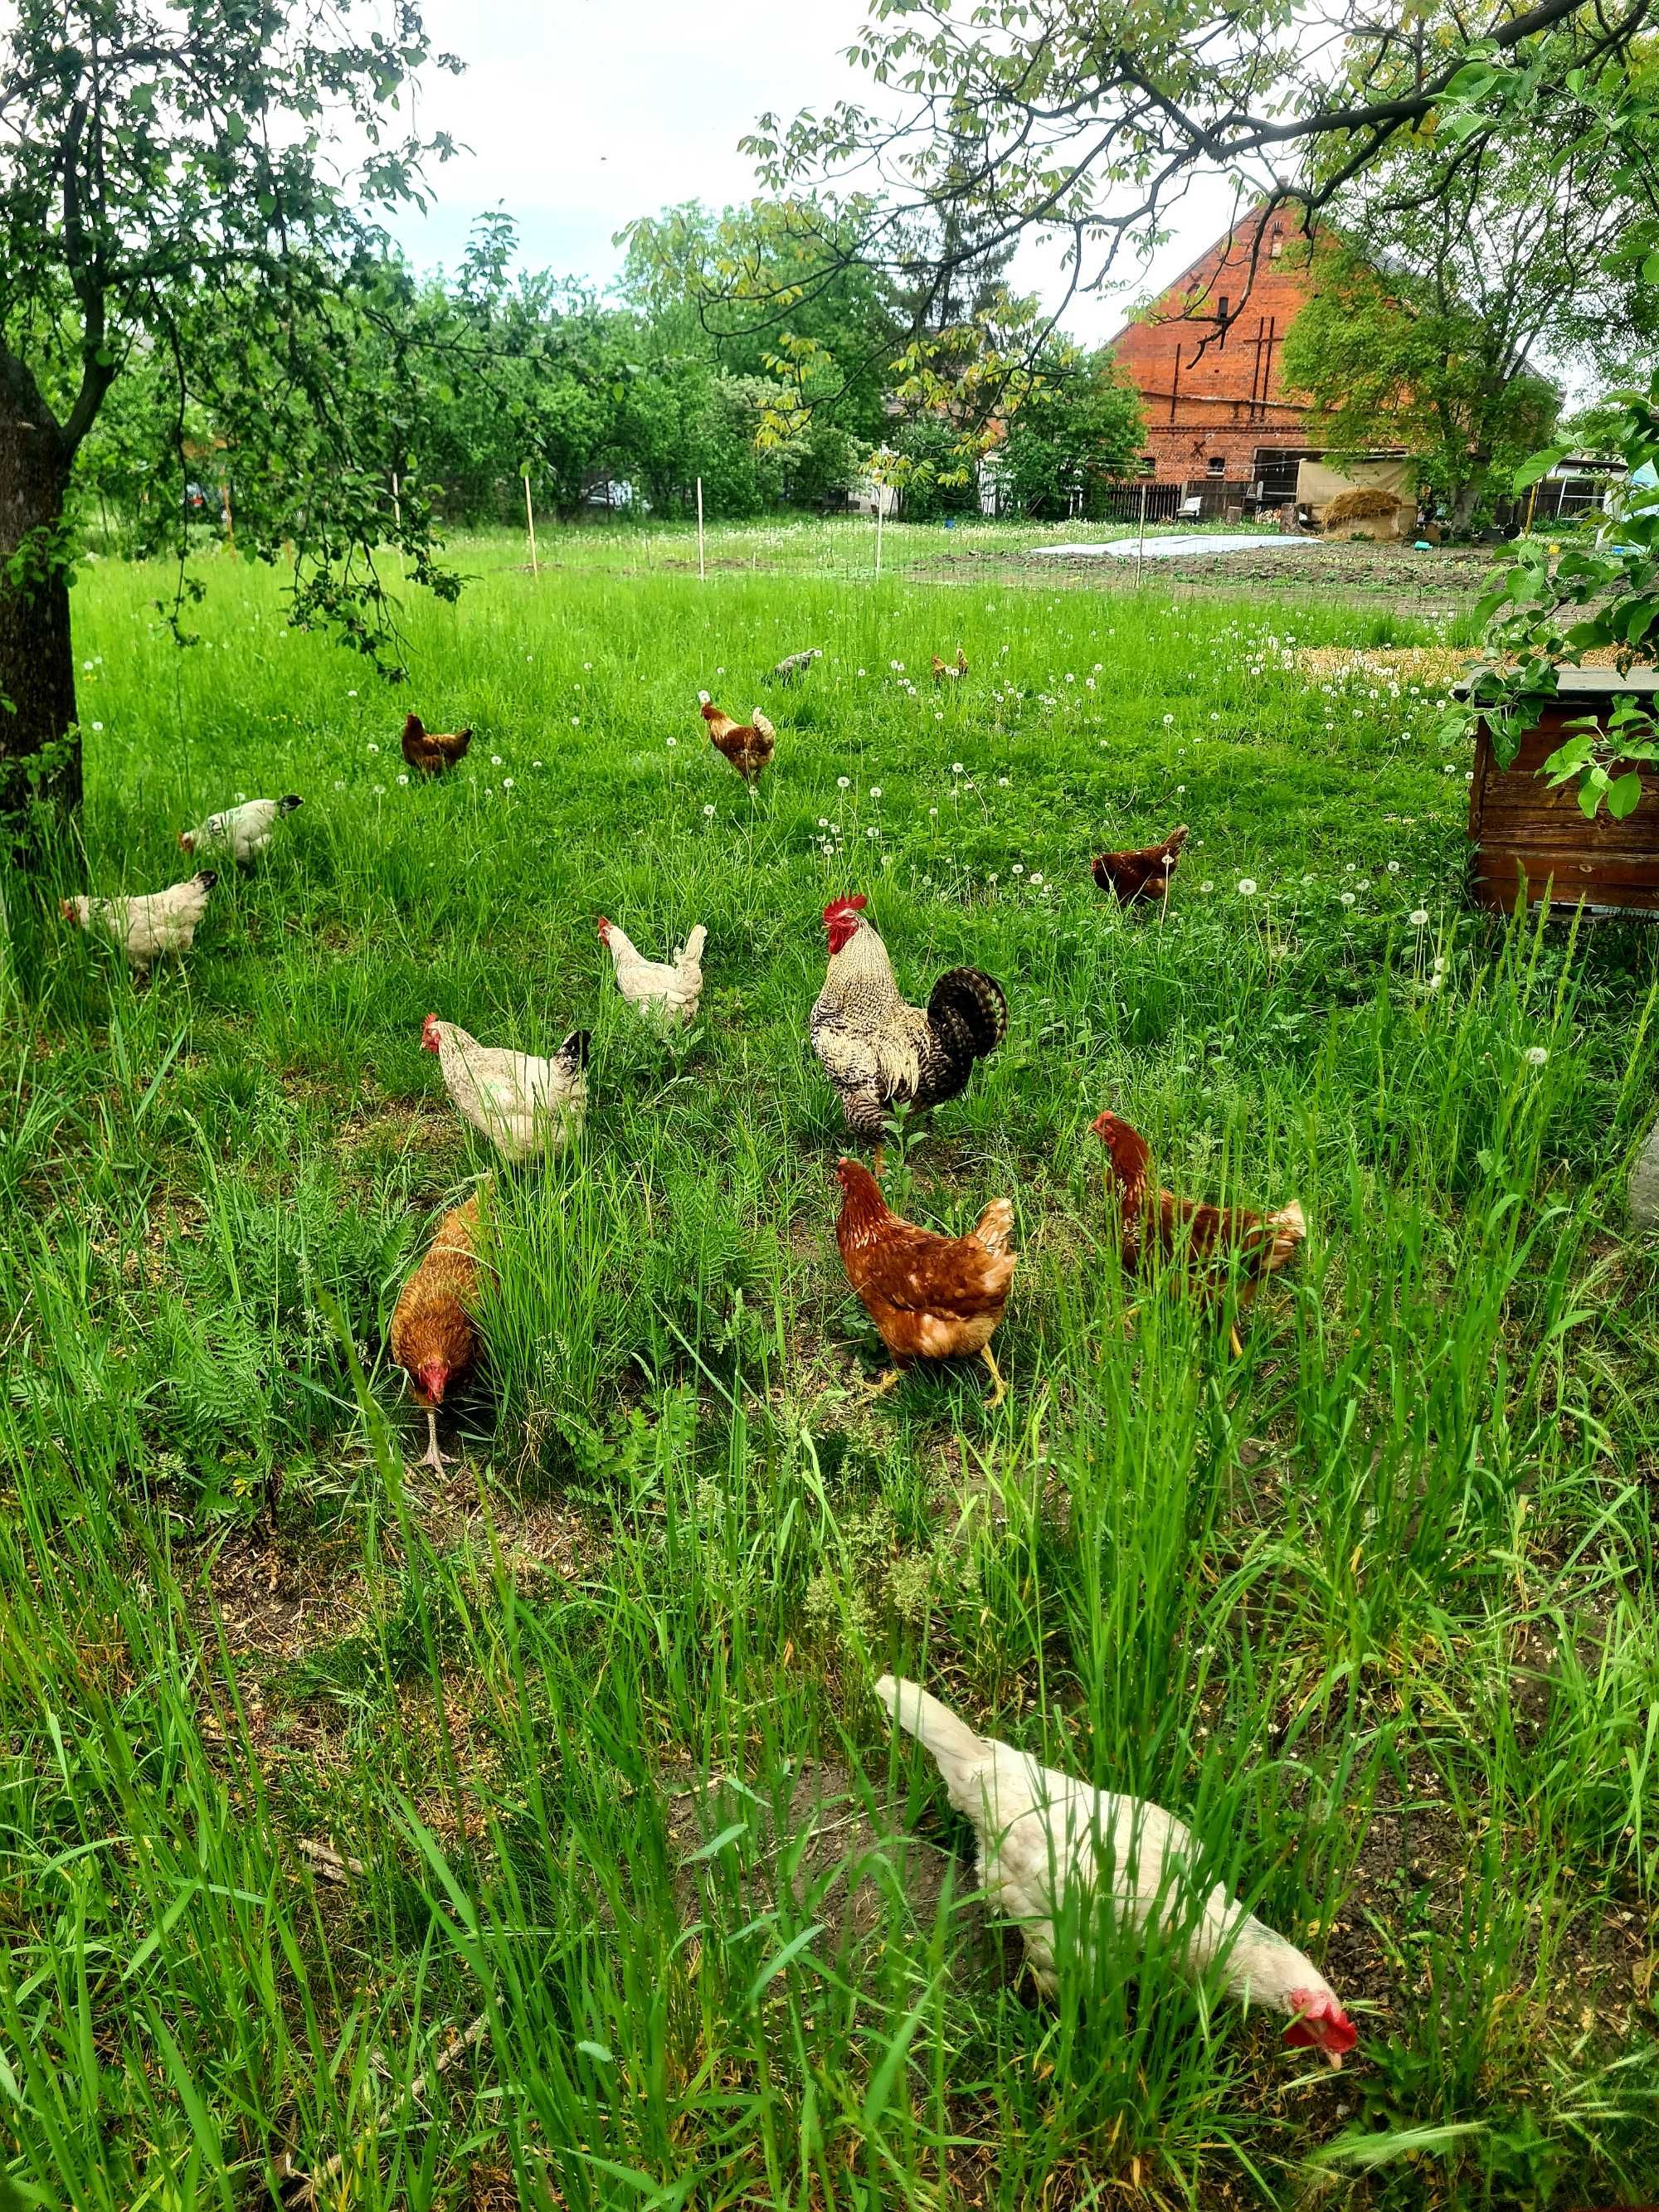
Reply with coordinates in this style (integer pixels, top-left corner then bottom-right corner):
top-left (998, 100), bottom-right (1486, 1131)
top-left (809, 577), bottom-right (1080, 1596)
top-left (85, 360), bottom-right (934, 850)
top-left (836, 1159), bottom-right (1015, 1405)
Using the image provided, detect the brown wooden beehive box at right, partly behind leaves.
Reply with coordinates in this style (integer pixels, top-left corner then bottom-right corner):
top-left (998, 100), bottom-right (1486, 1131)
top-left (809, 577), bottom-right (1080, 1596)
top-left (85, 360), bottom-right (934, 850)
top-left (1469, 668), bottom-right (1659, 913)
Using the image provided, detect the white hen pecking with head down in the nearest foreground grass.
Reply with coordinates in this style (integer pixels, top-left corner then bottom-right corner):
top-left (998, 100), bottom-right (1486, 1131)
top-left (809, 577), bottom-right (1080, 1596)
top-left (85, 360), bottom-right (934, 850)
top-left (876, 1675), bottom-right (1358, 2069)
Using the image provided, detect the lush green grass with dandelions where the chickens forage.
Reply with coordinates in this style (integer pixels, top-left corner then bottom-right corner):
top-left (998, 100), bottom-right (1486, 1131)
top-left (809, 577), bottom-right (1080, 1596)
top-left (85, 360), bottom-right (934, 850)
top-left (0, 533), bottom-right (1659, 2212)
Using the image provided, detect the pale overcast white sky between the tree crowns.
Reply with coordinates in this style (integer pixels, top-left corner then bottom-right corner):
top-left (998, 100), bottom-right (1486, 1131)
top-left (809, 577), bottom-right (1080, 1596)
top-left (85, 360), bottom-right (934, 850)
top-left (396, 0), bottom-right (1230, 343)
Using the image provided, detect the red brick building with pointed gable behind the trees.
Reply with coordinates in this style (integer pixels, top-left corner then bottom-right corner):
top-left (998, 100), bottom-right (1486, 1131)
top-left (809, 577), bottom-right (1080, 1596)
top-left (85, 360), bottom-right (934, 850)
top-left (1112, 208), bottom-right (1321, 504)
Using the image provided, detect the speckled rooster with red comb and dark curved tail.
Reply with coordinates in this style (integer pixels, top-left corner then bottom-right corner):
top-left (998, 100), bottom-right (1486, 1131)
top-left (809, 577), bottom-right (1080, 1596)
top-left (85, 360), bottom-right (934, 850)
top-left (807, 893), bottom-right (1009, 1173)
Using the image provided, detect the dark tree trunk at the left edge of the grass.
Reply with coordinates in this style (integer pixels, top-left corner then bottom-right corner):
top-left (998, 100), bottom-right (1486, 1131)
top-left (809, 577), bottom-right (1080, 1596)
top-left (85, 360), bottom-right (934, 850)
top-left (0, 389), bottom-right (80, 814)
